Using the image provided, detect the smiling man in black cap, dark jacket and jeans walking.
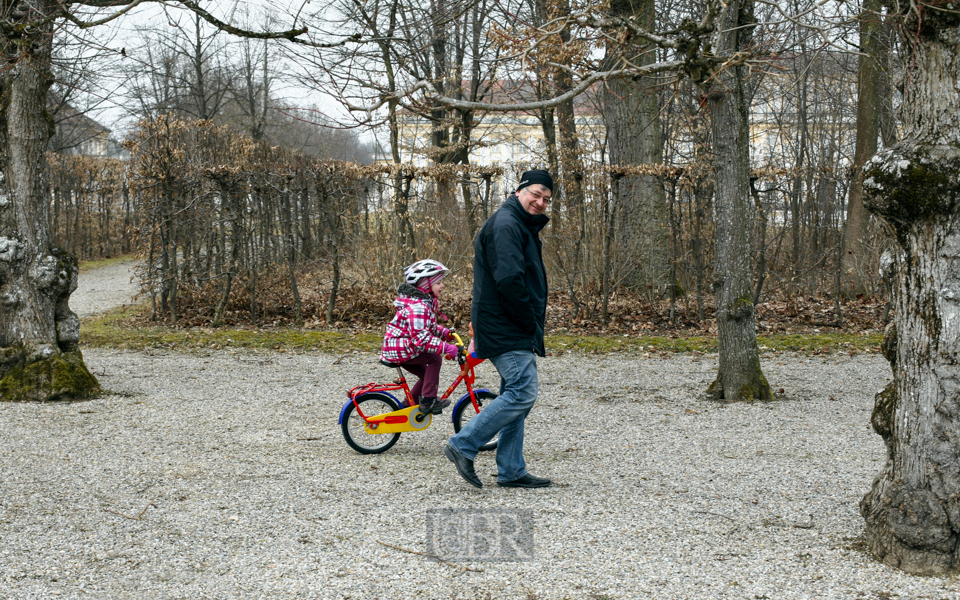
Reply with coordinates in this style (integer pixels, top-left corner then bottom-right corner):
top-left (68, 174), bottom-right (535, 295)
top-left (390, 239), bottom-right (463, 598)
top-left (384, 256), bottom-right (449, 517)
top-left (443, 169), bottom-right (553, 488)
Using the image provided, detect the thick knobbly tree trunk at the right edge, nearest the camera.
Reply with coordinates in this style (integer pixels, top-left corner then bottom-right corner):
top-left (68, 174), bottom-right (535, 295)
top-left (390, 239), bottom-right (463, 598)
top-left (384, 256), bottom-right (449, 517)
top-left (860, 3), bottom-right (960, 574)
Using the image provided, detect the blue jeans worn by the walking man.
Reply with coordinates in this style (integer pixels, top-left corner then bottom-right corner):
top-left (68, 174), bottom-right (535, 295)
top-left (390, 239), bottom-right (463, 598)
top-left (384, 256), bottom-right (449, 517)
top-left (449, 350), bottom-right (537, 483)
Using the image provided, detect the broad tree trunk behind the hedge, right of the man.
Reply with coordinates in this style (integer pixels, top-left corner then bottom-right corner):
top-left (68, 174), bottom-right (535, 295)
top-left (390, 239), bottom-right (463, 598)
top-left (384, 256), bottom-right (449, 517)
top-left (603, 0), bottom-right (670, 293)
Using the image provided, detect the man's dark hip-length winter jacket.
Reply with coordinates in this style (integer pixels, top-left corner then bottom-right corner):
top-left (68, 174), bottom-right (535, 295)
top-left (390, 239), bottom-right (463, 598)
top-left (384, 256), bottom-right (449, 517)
top-left (470, 194), bottom-right (550, 358)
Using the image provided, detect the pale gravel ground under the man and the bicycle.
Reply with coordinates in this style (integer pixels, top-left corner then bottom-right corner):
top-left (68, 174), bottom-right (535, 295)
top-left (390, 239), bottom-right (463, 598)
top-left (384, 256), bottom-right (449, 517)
top-left (0, 266), bottom-right (960, 600)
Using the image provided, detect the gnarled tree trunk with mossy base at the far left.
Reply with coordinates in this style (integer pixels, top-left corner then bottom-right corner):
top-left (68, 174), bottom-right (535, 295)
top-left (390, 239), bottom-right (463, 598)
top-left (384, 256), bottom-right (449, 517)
top-left (0, 8), bottom-right (100, 401)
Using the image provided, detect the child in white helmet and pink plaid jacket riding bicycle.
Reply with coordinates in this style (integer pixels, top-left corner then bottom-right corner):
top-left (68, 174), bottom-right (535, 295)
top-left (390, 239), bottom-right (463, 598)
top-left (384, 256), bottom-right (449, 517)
top-left (380, 259), bottom-right (459, 414)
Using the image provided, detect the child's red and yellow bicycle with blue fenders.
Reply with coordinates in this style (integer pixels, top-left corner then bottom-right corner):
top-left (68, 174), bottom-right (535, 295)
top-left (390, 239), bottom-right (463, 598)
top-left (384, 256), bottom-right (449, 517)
top-left (339, 333), bottom-right (497, 454)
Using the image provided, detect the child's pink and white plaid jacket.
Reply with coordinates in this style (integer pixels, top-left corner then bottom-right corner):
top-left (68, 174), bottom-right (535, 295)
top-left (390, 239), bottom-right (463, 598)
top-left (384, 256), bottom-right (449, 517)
top-left (380, 284), bottom-right (450, 363)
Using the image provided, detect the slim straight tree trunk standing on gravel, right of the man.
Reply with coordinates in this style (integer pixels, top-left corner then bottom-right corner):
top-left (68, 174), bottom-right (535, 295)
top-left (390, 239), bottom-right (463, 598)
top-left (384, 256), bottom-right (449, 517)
top-left (707, 0), bottom-right (773, 402)
